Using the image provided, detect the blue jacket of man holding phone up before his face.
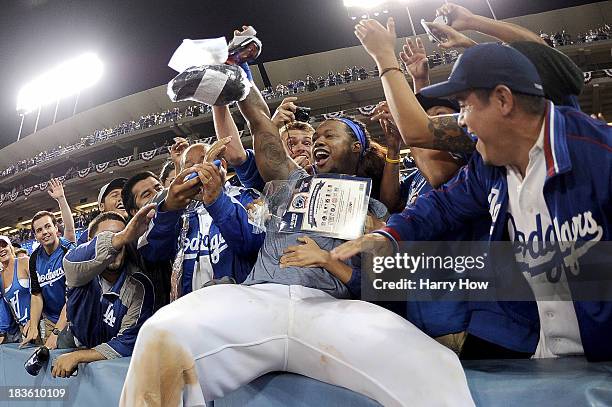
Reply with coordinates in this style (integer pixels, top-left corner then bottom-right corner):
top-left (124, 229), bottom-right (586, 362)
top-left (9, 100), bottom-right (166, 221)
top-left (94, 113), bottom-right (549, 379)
top-left (138, 187), bottom-right (265, 295)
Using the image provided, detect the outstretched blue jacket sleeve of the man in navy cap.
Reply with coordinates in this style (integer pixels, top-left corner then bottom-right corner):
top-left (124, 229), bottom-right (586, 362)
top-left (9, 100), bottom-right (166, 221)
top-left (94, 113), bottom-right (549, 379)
top-left (378, 154), bottom-right (488, 241)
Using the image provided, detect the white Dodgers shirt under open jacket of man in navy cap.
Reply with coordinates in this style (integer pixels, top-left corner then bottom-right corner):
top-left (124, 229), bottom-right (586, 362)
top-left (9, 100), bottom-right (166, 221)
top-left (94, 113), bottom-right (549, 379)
top-left (506, 124), bottom-right (584, 358)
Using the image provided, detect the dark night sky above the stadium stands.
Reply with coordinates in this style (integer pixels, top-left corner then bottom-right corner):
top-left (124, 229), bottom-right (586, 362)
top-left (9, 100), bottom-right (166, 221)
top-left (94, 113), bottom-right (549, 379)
top-left (0, 0), bottom-right (594, 147)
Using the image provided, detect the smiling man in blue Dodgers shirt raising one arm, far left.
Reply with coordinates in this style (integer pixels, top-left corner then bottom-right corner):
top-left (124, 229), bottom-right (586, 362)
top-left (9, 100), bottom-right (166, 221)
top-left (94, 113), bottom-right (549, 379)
top-left (22, 179), bottom-right (76, 349)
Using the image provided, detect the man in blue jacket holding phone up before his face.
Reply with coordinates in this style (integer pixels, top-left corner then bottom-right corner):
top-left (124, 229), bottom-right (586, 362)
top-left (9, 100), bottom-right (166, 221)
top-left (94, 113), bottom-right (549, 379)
top-left (139, 142), bottom-right (264, 299)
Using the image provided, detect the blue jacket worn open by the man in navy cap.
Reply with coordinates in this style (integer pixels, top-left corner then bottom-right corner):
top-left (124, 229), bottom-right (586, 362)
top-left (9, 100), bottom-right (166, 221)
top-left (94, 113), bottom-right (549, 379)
top-left (379, 102), bottom-right (612, 360)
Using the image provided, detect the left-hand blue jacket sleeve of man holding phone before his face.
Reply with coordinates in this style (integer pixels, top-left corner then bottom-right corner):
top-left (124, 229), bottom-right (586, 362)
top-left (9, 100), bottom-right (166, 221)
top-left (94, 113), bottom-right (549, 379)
top-left (138, 203), bottom-right (183, 262)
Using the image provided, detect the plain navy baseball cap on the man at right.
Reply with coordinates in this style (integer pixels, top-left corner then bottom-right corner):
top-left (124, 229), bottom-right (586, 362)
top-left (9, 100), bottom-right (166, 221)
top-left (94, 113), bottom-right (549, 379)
top-left (421, 43), bottom-right (544, 98)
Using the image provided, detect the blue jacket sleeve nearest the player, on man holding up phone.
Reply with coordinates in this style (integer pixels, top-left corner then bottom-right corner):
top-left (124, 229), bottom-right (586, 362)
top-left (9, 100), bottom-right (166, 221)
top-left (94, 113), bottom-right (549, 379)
top-left (206, 189), bottom-right (265, 255)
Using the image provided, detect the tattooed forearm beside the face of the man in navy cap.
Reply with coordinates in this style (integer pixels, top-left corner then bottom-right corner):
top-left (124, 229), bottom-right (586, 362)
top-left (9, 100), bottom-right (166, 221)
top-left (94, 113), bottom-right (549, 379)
top-left (420, 115), bottom-right (476, 154)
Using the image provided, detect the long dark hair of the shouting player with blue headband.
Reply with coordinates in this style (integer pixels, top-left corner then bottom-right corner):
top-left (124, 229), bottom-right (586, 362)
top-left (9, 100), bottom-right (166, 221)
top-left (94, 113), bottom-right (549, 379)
top-left (331, 116), bottom-right (387, 199)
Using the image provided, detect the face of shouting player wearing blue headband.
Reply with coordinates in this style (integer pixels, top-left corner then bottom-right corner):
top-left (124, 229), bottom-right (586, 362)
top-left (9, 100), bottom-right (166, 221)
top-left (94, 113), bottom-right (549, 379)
top-left (312, 120), bottom-right (361, 175)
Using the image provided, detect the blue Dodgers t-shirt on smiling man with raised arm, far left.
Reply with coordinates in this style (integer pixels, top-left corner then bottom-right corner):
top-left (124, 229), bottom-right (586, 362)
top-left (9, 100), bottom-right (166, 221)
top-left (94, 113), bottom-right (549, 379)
top-left (30, 237), bottom-right (76, 323)
